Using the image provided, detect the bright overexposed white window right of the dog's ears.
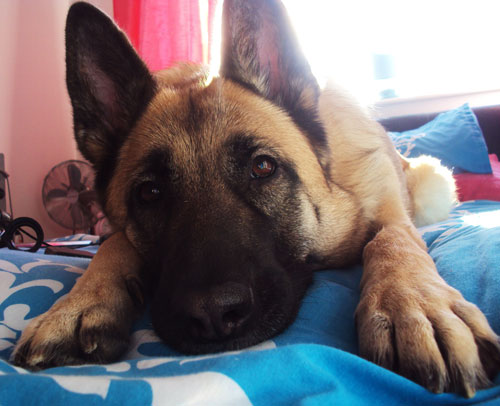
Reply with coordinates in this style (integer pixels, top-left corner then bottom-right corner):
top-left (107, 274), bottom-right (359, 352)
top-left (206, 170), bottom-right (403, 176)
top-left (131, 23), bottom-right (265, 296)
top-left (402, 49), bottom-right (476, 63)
top-left (284, 0), bottom-right (500, 101)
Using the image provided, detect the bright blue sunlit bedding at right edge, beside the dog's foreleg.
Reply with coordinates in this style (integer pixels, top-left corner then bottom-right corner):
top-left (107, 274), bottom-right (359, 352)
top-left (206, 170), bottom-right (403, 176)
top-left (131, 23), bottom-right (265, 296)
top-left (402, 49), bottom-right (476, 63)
top-left (419, 200), bottom-right (500, 334)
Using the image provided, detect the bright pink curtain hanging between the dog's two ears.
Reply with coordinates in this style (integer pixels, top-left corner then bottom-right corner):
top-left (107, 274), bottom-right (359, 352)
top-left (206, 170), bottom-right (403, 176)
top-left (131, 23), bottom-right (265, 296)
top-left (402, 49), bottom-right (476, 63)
top-left (113, 0), bottom-right (217, 71)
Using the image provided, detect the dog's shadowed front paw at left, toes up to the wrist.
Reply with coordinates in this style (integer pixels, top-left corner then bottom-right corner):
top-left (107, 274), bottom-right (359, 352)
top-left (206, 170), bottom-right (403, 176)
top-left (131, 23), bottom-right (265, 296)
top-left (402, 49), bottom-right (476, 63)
top-left (12, 295), bottom-right (130, 370)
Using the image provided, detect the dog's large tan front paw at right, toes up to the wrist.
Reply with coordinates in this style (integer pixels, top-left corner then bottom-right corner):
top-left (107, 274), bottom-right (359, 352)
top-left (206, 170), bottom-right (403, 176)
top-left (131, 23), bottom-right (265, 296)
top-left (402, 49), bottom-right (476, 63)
top-left (356, 279), bottom-right (500, 397)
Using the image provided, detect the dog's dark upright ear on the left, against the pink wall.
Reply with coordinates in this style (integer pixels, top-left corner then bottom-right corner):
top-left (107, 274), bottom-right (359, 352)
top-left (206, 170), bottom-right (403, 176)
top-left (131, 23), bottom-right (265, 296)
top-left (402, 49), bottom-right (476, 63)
top-left (66, 3), bottom-right (155, 167)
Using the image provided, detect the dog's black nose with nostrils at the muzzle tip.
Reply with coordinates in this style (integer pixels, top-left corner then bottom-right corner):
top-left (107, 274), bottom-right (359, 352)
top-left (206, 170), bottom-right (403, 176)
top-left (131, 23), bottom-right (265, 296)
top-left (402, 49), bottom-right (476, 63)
top-left (184, 282), bottom-right (254, 340)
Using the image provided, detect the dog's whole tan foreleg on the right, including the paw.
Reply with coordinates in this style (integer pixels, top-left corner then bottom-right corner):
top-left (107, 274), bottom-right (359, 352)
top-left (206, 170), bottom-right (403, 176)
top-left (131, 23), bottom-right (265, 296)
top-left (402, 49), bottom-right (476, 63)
top-left (356, 203), bottom-right (500, 397)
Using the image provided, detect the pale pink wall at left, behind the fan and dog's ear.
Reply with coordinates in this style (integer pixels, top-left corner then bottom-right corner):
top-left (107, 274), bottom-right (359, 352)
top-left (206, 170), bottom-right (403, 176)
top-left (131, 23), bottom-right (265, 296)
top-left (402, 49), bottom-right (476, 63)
top-left (0, 0), bottom-right (113, 237)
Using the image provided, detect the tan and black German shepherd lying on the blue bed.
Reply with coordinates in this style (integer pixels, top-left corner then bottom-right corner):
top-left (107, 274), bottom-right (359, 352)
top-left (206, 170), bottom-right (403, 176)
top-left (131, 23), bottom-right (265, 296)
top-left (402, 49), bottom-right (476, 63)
top-left (13, 0), bottom-right (500, 397)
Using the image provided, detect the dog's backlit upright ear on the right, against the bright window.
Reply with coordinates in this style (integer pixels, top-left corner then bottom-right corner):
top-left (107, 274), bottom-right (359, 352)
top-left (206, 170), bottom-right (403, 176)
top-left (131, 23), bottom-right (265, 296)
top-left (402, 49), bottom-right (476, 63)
top-left (220, 0), bottom-right (319, 119)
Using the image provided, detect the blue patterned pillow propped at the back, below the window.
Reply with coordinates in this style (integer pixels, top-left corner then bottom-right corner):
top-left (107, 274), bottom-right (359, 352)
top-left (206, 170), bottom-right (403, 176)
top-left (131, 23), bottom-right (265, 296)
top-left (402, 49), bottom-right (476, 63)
top-left (389, 104), bottom-right (491, 173)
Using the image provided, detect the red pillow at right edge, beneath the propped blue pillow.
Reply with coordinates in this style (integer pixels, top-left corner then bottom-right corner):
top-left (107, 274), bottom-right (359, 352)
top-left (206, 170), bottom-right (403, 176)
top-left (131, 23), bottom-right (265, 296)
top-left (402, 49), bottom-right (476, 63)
top-left (453, 154), bottom-right (500, 202)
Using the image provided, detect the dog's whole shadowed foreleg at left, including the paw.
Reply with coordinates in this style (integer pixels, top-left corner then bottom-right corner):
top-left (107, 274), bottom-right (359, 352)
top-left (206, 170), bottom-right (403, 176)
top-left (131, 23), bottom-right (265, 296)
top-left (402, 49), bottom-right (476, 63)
top-left (12, 233), bottom-right (143, 370)
